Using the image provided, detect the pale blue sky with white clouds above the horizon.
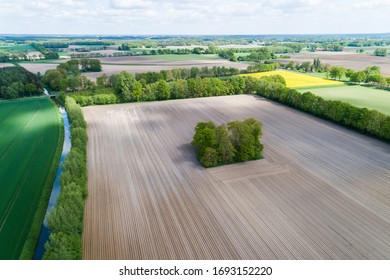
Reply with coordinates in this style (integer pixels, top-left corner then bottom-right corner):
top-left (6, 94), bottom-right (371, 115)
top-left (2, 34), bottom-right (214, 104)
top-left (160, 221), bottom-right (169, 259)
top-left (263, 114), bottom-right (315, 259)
top-left (0, 0), bottom-right (390, 35)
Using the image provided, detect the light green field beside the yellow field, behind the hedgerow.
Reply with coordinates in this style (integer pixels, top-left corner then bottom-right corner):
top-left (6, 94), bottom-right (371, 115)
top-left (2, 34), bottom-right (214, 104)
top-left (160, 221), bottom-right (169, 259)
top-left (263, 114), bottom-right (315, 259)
top-left (299, 85), bottom-right (390, 115)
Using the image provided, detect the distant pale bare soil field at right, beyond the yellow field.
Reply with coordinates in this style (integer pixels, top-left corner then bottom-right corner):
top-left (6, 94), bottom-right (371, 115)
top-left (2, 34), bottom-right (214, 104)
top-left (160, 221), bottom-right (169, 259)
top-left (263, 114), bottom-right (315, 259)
top-left (277, 52), bottom-right (390, 76)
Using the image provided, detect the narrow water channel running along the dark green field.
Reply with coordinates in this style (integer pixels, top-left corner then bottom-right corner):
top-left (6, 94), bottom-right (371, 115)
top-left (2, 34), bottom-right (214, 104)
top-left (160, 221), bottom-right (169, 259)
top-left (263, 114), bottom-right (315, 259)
top-left (33, 107), bottom-right (71, 260)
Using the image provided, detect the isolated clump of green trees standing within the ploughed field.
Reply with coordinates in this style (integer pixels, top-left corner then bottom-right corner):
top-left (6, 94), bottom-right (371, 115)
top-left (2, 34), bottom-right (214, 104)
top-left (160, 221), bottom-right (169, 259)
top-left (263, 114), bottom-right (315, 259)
top-left (191, 118), bottom-right (263, 167)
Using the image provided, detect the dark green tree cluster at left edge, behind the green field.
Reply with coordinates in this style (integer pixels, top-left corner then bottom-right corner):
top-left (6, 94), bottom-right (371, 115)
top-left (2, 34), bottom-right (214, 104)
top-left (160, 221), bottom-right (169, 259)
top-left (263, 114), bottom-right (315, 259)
top-left (0, 67), bottom-right (43, 99)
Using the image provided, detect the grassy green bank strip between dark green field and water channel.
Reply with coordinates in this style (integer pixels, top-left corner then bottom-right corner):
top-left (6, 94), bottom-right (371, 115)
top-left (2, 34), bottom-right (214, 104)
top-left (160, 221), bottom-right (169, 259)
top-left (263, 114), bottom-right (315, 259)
top-left (19, 101), bottom-right (65, 260)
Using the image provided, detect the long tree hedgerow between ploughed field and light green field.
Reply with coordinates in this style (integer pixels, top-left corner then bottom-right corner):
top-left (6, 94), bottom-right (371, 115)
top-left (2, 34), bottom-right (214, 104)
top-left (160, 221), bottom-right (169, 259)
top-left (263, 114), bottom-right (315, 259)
top-left (252, 79), bottom-right (390, 140)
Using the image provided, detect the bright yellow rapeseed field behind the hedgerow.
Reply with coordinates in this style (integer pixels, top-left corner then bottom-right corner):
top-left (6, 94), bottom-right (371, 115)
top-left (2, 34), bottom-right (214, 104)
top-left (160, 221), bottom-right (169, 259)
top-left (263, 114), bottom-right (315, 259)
top-left (242, 70), bottom-right (343, 88)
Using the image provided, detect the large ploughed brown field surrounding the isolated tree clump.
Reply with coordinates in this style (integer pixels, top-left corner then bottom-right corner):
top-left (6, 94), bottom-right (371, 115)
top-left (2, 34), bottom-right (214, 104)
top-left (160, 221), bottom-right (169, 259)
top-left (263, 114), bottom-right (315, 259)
top-left (83, 95), bottom-right (390, 259)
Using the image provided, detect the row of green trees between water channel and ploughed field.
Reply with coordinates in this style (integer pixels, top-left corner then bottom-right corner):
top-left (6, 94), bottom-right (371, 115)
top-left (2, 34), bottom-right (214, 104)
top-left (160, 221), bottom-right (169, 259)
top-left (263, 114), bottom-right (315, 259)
top-left (43, 97), bottom-right (88, 260)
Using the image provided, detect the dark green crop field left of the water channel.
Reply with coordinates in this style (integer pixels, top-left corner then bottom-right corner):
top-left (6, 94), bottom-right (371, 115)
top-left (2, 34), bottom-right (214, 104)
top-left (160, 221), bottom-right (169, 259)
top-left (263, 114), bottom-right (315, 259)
top-left (0, 98), bottom-right (62, 259)
